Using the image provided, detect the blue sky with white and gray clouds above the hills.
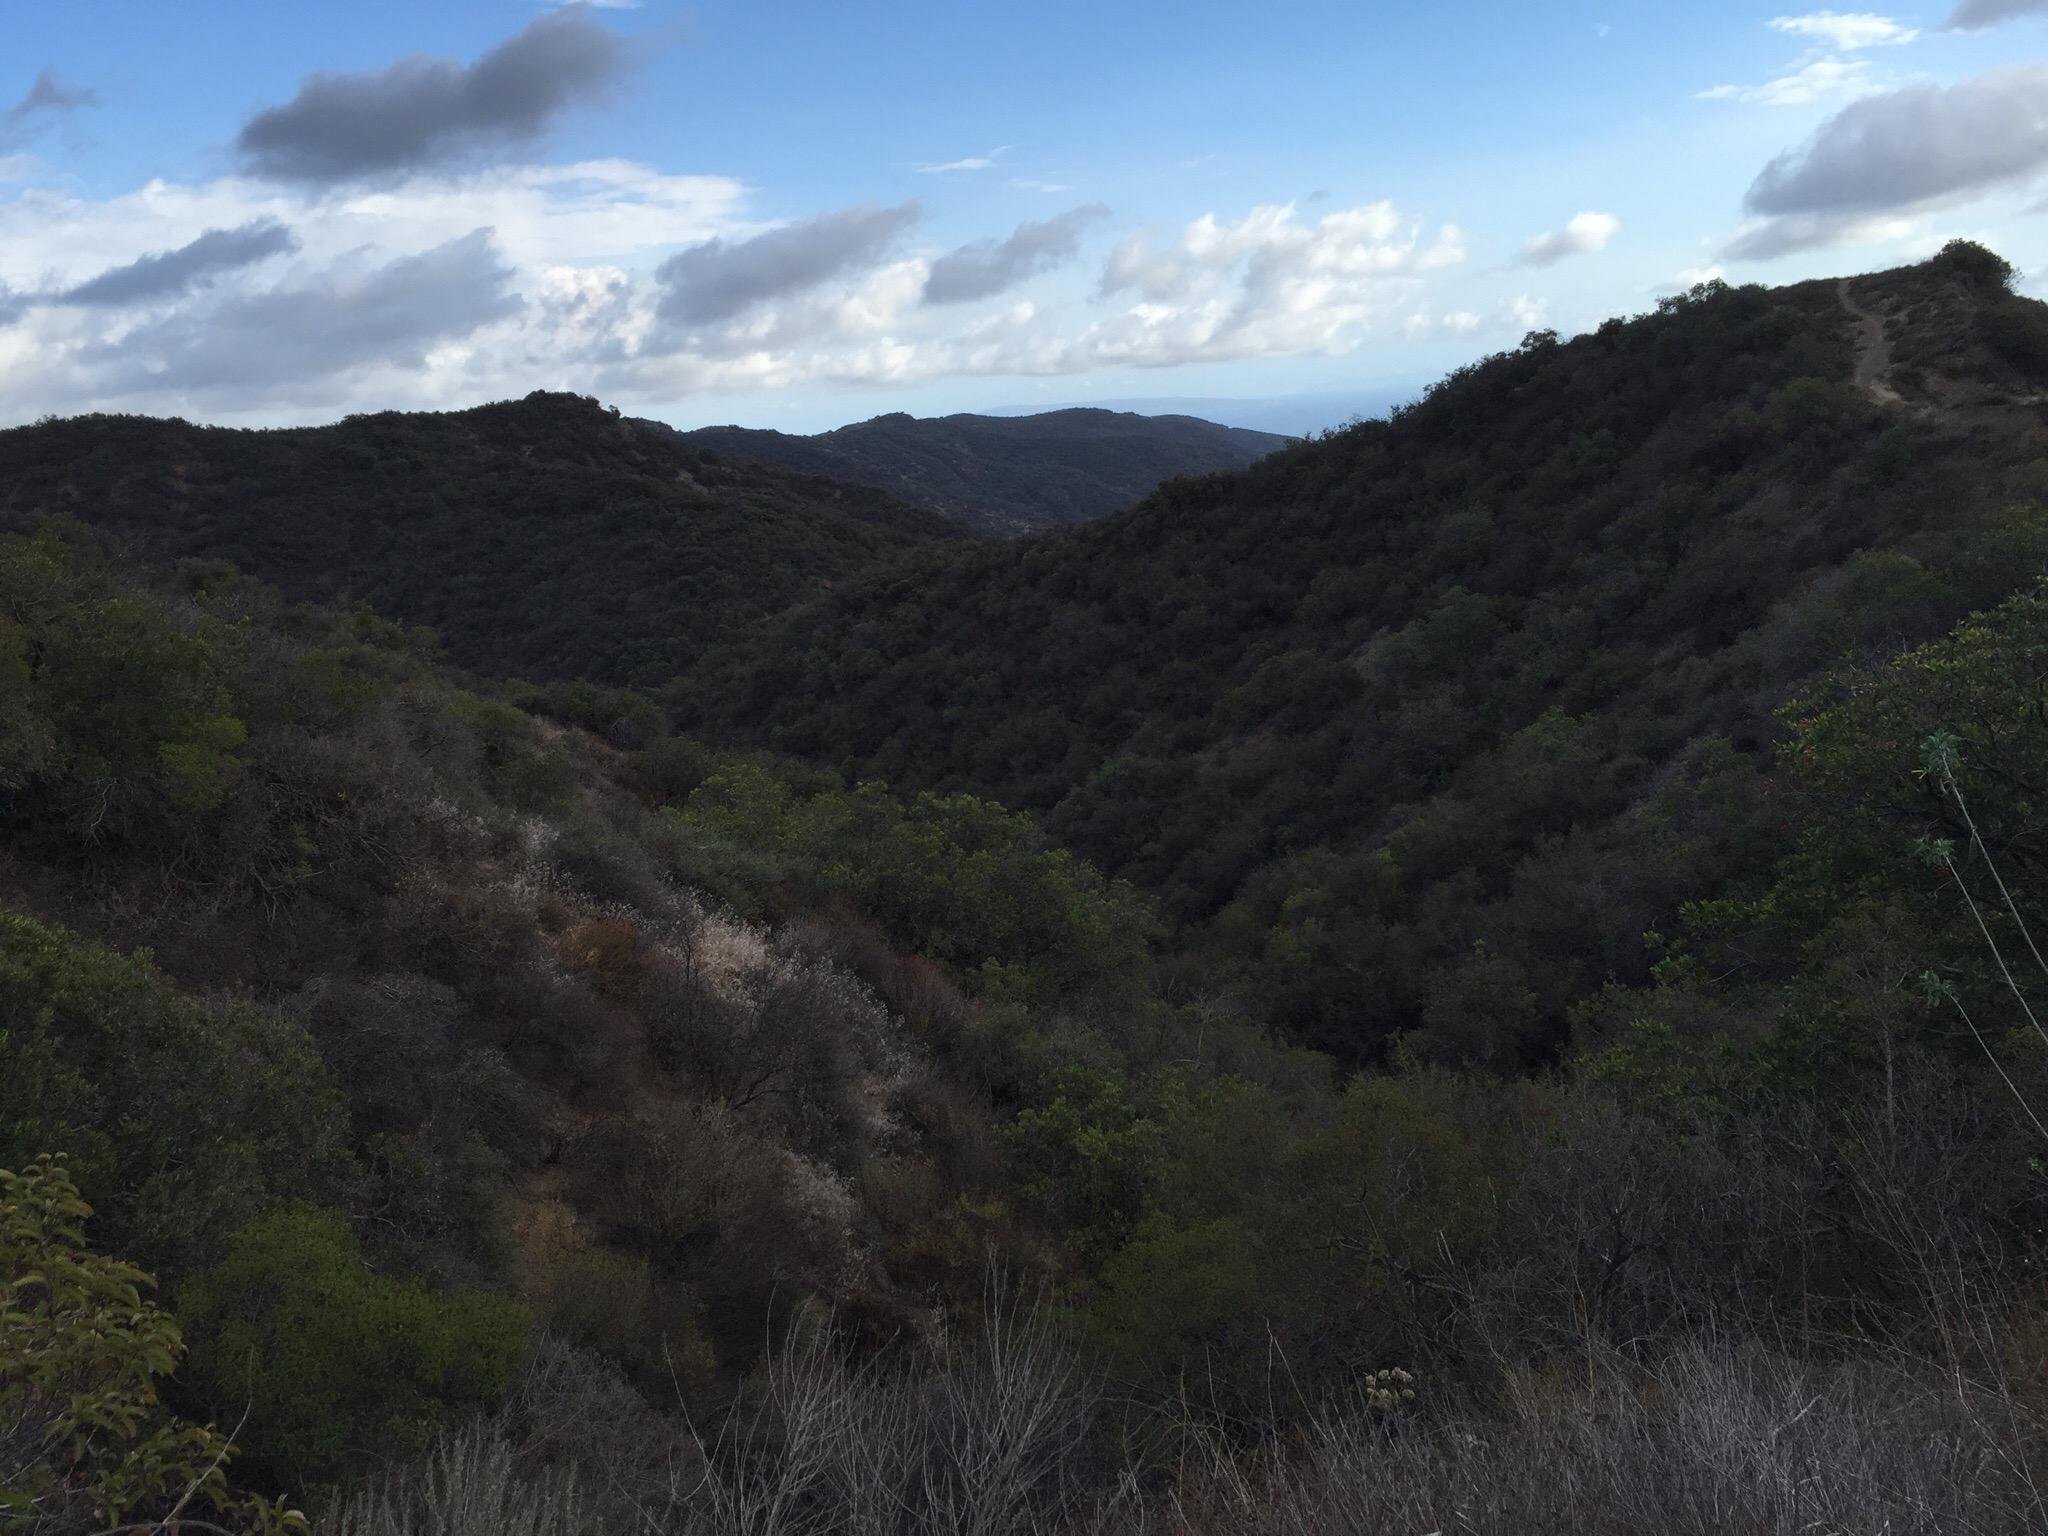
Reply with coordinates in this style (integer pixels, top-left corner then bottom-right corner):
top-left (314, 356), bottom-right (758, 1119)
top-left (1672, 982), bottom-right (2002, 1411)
top-left (0, 0), bottom-right (2048, 432)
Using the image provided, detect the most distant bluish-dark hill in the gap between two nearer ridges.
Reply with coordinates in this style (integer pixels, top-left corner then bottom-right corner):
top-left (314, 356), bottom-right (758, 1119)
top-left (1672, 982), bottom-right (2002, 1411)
top-left (682, 410), bottom-right (1288, 532)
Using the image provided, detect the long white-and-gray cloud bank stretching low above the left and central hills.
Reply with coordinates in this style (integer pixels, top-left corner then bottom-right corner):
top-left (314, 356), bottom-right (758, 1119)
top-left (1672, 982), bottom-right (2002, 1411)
top-left (0, 129), bottom-right (1490, 424)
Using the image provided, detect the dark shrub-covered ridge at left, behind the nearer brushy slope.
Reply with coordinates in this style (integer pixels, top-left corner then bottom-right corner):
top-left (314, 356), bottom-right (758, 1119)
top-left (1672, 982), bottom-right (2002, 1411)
top-left (0, 393), bottom-right (961, 682)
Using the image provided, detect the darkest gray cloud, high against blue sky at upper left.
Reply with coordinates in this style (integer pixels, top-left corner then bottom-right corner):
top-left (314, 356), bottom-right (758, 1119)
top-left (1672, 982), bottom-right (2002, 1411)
top-left (236, 6), bottom-right (625, 182)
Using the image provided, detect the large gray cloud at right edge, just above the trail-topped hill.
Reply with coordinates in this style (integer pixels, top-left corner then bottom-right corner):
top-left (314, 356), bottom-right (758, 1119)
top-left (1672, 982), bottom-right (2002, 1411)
top-left (1743, 63), bottom-right (2048, 217)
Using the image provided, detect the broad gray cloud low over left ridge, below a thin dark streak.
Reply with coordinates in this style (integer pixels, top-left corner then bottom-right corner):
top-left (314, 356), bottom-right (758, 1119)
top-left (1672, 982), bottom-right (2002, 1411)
top-left (88, 229), bottom-right (520, 393)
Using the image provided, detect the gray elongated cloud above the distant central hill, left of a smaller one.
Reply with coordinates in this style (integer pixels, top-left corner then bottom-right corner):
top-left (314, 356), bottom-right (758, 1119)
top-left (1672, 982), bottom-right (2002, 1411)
top-left (655, 203), bottom-right (918, 326)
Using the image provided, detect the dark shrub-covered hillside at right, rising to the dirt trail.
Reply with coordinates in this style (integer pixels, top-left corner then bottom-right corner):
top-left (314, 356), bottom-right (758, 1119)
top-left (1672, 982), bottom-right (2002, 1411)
top-left (676, 248), bottom-right (2048, 1061)
